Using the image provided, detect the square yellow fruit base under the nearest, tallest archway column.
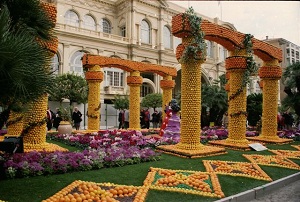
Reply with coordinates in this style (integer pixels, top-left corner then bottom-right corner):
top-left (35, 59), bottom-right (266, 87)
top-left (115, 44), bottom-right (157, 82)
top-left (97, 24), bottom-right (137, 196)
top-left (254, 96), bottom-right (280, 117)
top-left (156, 145), bottom-right (227, 158)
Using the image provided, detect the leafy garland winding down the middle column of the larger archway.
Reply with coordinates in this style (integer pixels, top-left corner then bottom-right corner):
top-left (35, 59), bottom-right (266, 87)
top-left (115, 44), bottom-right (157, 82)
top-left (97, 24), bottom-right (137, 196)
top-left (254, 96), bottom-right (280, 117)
top-left (228, 34), bottom-right (258, 117)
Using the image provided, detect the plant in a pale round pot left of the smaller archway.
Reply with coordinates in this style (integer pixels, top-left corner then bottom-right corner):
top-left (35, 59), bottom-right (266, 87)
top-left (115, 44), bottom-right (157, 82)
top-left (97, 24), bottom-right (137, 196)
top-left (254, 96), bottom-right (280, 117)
top-left (57, 106), bottom-right (72, 134)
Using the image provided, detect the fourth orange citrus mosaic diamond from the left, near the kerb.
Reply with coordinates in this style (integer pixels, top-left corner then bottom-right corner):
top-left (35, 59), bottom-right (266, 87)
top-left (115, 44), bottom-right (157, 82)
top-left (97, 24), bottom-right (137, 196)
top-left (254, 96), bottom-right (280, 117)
top-left (243, 154), bottom-right (300, 170)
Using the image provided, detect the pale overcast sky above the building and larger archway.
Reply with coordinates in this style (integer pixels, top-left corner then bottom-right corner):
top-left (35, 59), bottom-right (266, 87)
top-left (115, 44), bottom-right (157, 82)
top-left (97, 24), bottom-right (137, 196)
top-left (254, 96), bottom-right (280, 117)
top-left (170, 0), bottom-right (300, 46)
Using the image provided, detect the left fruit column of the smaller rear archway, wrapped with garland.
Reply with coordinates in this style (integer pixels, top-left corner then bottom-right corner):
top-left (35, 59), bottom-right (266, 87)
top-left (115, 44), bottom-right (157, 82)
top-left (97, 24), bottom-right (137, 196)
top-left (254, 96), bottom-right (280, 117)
top-left (85, 65), bottom-right (103, 131)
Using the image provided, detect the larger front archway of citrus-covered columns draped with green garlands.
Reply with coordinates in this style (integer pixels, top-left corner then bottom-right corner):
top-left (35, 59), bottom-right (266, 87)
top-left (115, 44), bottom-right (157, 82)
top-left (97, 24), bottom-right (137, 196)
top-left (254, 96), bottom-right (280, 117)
top-left (159, 10), bottom-right (285, 157)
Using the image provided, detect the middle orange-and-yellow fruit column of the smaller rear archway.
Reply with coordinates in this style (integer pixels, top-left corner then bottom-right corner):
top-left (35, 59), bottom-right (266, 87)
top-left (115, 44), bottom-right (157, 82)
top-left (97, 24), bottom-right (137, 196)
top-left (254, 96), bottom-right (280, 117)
top-left (127, 71), bottom-right (143, 130)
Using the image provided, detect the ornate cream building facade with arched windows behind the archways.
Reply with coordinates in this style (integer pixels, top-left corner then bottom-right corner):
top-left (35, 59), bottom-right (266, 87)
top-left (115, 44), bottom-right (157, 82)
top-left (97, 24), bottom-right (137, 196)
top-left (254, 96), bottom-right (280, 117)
top-left (48, 0), bottom-right (236, 128)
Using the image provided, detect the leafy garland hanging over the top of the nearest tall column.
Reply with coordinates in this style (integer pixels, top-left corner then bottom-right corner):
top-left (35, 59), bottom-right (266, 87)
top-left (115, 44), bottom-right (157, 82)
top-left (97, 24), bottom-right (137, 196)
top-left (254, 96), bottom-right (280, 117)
top-left (179, 7), bottom-right (206, 63)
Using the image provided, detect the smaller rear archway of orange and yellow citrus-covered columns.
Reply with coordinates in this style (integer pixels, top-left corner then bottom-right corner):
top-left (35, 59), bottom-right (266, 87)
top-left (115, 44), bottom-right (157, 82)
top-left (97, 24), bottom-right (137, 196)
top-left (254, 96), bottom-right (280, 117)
top-left (82, 54), bottom-right (177, 131)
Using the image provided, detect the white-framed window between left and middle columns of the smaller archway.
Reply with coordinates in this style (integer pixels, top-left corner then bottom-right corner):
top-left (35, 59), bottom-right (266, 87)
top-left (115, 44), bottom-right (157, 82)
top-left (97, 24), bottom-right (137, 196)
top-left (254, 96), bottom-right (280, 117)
top-left (104, 68), bottom-right (124, 87)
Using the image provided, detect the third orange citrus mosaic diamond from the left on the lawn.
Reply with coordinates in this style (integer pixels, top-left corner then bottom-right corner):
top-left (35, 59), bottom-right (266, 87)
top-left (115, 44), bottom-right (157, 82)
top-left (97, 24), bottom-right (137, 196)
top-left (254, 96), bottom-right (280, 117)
top-left (203, 160), bottom-right (272, 181)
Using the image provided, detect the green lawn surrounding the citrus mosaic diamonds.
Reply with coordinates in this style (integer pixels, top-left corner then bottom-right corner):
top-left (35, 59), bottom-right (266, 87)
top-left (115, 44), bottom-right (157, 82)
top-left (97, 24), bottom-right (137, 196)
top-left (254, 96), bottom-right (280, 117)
top-left (0, 141), bottom-right (300, 202)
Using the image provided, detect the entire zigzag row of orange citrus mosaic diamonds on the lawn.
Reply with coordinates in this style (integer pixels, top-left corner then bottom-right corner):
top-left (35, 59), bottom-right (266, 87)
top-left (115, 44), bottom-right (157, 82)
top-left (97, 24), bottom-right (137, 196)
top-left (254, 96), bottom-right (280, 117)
top-left (42, 145), bottom-right (300, 202)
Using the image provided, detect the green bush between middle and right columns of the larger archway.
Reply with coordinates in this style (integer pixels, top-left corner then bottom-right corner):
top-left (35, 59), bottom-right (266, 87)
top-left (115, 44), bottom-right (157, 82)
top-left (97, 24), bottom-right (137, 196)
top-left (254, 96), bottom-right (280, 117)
top-left (247, 93), bottom-right (263, 126)
